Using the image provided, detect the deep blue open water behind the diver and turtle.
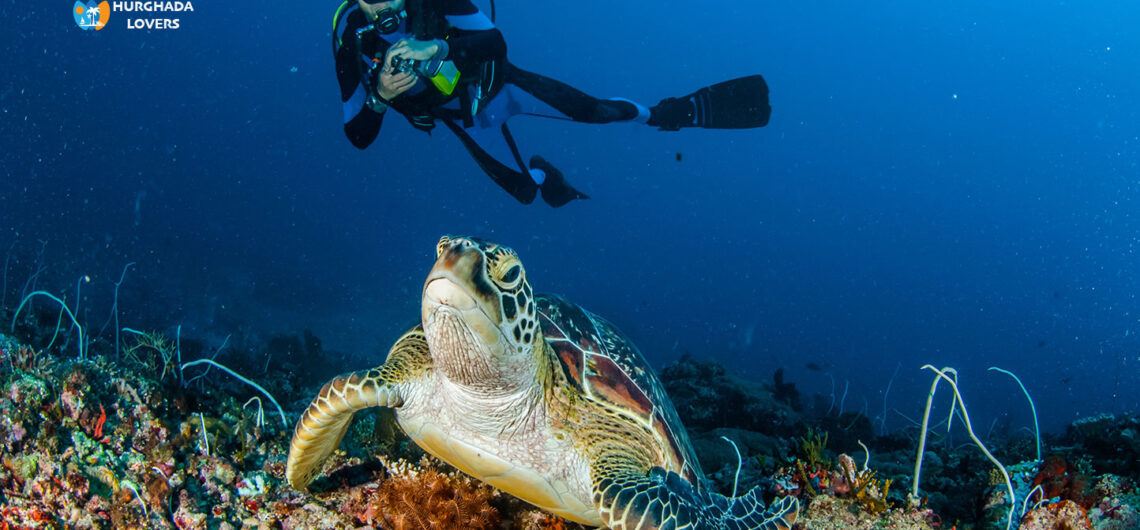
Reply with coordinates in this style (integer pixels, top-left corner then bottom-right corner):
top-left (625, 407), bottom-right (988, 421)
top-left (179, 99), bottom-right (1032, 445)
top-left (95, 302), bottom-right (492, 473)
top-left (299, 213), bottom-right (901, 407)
top-left (0, 0), bottom-right (1140, 442)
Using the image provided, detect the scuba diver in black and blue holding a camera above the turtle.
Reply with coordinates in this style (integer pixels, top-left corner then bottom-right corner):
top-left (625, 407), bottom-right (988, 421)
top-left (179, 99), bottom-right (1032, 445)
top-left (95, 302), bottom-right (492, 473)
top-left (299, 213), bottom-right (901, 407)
top-left (333, 0), bottom-right (771, 207)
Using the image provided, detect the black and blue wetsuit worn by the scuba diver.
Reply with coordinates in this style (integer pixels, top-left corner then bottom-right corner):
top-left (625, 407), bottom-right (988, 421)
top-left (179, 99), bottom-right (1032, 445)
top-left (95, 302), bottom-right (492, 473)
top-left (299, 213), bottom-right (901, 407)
top-left (333, 0), bottom-right (650, 206)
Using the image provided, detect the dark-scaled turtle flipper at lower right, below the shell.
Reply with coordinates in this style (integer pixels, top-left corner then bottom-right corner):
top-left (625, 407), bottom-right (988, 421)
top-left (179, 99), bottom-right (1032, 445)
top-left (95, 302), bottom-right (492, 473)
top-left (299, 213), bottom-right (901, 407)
top-left (593, 462), bottom-right (799, 530)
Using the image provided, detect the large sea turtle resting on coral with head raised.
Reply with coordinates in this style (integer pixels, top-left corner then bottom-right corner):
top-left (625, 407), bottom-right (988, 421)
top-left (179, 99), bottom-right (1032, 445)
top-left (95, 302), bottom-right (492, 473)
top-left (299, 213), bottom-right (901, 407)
top-left (285, 237), bottom-right (799, 530)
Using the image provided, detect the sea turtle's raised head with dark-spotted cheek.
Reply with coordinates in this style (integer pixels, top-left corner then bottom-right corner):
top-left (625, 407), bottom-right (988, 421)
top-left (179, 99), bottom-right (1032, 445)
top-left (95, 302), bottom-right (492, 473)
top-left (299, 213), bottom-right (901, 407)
top-left (422, 236), bottom-right (543, 388)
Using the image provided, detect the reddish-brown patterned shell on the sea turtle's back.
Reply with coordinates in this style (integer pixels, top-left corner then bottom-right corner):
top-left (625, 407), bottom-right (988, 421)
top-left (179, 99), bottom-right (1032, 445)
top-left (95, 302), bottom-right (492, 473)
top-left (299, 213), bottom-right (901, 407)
top-left (536, 294), bottom-right (705, 487)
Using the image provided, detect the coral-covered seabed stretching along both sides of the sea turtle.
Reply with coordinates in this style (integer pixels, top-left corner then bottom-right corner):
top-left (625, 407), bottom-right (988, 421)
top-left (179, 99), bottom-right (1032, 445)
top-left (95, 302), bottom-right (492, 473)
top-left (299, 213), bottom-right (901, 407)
top-left (0, 311), bottom-right (1140, 530)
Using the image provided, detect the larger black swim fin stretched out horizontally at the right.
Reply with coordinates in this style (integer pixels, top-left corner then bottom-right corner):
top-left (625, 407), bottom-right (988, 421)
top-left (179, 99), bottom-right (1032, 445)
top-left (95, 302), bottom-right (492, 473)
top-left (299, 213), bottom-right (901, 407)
top-left (649, 75), bottom-right (772, 131)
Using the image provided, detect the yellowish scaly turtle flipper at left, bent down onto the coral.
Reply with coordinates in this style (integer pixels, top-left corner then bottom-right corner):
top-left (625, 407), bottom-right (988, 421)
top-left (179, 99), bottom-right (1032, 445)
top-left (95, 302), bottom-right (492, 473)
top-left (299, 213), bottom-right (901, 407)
top-left (285, 326), bottom-right (431, 491)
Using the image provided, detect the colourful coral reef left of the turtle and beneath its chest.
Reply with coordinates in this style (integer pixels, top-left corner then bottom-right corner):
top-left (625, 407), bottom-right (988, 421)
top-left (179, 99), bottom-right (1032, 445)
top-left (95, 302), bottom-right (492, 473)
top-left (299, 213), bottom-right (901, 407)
top-left (0, 321), bottom-right (583, 530)
